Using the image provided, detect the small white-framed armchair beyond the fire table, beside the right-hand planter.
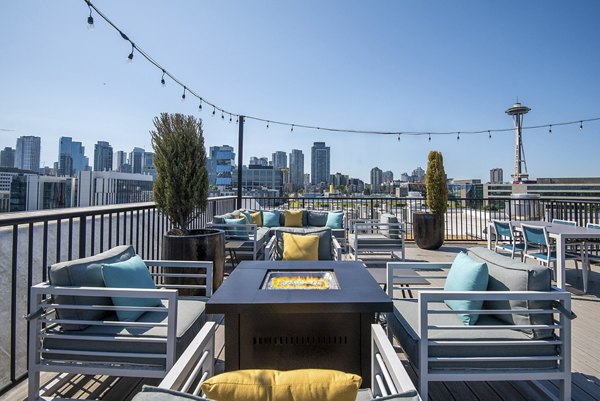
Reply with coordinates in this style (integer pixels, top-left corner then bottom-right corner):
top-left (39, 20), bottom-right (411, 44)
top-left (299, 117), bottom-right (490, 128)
top-left (348, 213), bottom-right (405, 260)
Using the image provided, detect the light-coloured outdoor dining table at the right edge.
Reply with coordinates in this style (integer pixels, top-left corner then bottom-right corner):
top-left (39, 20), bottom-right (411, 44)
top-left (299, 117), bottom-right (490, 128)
top-left (488, 220), bottom-right (600, 292)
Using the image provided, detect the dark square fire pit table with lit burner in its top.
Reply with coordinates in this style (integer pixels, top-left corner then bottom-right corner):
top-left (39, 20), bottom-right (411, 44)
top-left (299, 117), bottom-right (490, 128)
top-left (206, 261), bottom-right (393, 387)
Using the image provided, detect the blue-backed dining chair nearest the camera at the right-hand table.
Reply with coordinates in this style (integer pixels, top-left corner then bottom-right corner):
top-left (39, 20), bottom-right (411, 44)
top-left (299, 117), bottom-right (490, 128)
top-left (521, 224), bottom-right (585, 277)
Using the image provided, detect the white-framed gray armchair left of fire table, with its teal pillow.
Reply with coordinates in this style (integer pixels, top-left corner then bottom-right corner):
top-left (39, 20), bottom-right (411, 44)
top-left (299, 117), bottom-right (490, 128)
top-left (27, 245), bottom-right (213, 401)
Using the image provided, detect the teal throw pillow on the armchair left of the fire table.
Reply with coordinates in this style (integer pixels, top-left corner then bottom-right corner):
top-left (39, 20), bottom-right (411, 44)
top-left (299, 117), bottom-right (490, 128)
top-left (102, 255), bottom-right (162, 322)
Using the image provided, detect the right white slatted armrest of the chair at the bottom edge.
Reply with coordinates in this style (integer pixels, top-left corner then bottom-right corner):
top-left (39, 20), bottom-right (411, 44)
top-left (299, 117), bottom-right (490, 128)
top-left (371, 324), bottom-right (421, 400)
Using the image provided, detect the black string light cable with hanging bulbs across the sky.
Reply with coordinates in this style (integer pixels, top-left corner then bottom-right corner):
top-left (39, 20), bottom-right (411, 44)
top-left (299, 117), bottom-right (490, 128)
top-left (83, 0), bottom-right (600, 141)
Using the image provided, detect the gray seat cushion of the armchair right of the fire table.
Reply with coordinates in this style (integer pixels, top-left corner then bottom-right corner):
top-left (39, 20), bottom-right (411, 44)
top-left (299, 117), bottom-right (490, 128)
top-left (389, 299), bottom-right (557, 369)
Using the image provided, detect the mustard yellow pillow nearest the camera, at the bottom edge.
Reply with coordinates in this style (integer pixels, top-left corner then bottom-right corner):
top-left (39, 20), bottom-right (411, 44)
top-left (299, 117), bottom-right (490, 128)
top-left (202, 369), bottom-right (362, 401)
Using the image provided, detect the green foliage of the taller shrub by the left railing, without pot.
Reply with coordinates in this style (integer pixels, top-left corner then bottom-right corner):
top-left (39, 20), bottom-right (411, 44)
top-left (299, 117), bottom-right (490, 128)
top-left (150, 113), bottom-right (208, 235)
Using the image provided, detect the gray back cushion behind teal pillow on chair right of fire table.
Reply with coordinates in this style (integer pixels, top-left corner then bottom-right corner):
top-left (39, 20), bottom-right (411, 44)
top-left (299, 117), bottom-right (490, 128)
top-left (468, 247), bottom-right (553, 338)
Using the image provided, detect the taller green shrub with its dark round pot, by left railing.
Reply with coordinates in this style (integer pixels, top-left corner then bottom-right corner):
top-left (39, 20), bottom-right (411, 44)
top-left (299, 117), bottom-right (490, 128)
top-left (150, 113), bottom-right (225, 295)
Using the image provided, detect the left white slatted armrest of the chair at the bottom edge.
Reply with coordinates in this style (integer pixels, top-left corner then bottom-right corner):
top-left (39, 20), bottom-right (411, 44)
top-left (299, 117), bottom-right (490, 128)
top-left (158, 322), bottom-right (217, 395)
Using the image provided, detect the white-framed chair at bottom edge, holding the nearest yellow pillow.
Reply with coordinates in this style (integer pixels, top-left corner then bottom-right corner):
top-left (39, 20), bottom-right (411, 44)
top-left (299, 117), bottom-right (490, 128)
top-left (133, 322), bottom-right (421, 401)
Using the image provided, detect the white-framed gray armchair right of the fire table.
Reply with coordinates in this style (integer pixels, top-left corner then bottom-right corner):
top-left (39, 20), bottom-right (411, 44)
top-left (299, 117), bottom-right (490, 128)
top-left (387, 247), bottom-right (574, 400)
